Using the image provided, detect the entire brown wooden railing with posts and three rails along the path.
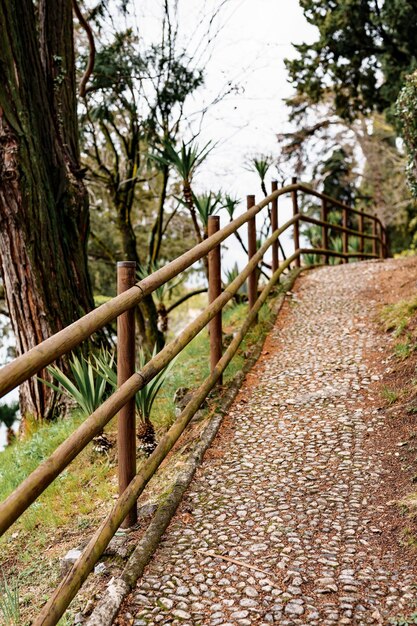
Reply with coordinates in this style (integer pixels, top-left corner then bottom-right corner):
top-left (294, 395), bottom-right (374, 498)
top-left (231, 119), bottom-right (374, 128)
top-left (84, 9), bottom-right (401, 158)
top-left (0, 179), bottom-right (387, 626)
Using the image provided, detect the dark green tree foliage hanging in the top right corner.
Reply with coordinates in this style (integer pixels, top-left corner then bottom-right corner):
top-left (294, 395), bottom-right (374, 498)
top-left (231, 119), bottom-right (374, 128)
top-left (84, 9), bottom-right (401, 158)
top-left (286, 0), bottom-right (417, 119)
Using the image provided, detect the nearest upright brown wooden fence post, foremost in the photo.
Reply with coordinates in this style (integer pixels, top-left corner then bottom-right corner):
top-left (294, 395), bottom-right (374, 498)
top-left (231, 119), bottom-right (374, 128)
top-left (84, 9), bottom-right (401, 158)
top-left (117, 261), bottom-right (137, 528)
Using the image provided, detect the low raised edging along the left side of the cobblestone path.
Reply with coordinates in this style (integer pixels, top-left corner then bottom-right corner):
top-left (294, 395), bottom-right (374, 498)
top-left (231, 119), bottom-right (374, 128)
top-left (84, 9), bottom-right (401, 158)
top-left (85, 268), bottom-right (302, 626)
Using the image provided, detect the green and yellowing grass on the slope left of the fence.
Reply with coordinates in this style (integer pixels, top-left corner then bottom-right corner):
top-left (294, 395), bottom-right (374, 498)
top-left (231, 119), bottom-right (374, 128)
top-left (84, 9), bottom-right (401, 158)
top-left (0, 284), bottom-right (284, 626)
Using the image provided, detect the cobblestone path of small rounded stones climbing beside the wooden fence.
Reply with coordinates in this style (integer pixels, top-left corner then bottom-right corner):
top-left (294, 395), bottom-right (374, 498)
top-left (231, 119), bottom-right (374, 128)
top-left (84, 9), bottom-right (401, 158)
top-left (124, 261), bottom-right (415, 626)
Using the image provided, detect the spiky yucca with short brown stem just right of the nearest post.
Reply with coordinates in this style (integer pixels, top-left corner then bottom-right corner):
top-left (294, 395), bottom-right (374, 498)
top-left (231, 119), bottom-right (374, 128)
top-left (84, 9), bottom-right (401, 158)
top-left (95, 347), bottom-right (176, 456)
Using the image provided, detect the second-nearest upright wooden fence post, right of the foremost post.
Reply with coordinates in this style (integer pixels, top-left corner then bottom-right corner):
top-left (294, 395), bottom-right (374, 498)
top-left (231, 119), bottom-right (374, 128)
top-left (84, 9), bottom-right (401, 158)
top-left (207, 215), bottom-right (223, 385)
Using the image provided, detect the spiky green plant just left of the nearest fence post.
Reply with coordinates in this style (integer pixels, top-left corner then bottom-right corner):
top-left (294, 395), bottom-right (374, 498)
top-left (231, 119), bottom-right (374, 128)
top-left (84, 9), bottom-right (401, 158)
top-left (42, 353), bottom-right (113, 416)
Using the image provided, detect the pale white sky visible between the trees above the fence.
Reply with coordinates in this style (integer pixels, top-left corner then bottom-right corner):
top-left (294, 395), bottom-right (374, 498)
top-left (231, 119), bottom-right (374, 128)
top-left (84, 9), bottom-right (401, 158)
top-left (137, 0), bottom-right (316, 266)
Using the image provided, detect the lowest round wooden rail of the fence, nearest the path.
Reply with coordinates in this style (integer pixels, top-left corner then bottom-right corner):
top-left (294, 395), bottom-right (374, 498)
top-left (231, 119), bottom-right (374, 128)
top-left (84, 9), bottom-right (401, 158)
top-left (33, 253), bottom-right (300, 626)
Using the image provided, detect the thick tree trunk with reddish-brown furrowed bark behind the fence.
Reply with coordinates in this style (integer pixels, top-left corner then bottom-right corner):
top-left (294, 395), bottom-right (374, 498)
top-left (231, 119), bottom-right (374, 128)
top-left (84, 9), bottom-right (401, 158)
top-left (0, 0), bottom-right (93, 419)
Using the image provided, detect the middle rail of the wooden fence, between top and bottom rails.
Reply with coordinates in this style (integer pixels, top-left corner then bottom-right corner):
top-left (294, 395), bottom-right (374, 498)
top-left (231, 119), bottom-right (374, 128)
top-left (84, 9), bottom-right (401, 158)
top-left (0, 217), bottom-right (298, 536)
